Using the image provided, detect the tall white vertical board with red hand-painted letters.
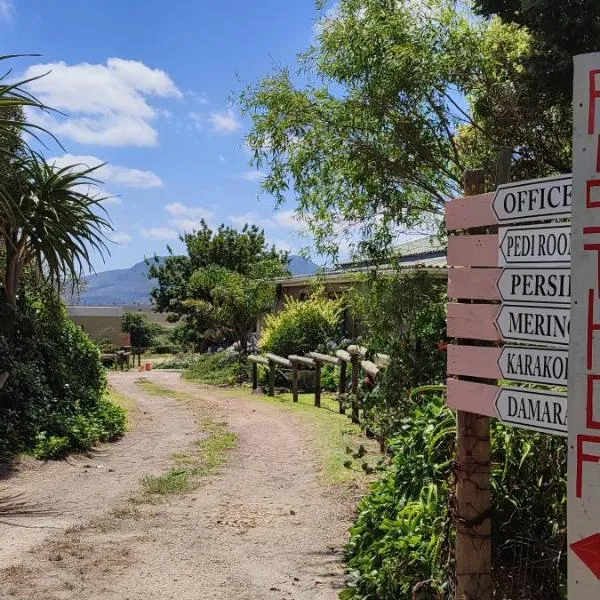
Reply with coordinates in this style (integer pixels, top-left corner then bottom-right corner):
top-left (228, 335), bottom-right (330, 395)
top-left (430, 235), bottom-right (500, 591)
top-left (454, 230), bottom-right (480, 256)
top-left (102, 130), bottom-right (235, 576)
top-left (568, 53), bottom-right (600, 600)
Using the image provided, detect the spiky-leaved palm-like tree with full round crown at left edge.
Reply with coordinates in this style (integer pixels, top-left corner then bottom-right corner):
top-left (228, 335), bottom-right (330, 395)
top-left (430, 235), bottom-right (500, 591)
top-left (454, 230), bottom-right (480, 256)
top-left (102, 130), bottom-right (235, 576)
top-left (0, 151), bottom-right (112, 322)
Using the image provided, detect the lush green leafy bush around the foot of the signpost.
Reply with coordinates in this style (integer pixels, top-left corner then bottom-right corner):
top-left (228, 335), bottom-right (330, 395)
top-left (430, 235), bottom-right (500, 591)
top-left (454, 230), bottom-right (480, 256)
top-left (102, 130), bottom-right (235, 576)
top-left (346, 393), bottom-right (566, 600)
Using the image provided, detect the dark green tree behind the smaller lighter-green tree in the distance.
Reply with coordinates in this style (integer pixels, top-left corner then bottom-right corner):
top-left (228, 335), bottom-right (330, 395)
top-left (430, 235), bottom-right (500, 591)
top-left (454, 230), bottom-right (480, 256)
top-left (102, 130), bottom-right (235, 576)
top-left (149, 221), bottom-right (287, 342)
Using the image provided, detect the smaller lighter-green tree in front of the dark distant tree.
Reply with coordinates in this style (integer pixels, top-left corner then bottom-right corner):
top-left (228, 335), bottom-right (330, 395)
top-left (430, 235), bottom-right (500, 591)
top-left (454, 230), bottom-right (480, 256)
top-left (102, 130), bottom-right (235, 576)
top-left (184, 260), bottom-right (286, 356)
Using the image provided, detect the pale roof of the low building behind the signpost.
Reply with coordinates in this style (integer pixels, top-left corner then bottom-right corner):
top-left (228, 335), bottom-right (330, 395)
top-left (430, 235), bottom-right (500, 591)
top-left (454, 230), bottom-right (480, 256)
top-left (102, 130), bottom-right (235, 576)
top-left (276, 235), bottom-right (448, 286)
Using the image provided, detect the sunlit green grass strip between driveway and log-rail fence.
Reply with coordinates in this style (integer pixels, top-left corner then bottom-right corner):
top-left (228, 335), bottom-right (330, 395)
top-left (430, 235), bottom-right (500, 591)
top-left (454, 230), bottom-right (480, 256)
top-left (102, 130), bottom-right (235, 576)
top-left (243, 390), bottom-right (381, 485)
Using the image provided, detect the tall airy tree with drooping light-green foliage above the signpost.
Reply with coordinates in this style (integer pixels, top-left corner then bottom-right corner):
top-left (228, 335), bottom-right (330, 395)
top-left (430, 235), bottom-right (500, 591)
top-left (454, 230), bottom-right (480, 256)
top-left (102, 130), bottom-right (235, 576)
top-left (240, 0), bottom-right (552, 258)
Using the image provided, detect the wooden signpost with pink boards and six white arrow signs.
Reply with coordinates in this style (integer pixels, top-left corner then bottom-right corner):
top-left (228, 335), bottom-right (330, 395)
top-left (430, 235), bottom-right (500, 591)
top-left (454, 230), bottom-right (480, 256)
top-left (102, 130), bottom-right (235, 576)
top-left (446, 150), bottom-right (576, 600)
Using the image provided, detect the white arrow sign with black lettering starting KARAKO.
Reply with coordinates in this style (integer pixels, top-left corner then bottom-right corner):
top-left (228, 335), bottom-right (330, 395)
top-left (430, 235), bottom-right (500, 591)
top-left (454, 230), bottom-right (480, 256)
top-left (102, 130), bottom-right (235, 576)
top-left (498, 346), bottom-right (569, 386)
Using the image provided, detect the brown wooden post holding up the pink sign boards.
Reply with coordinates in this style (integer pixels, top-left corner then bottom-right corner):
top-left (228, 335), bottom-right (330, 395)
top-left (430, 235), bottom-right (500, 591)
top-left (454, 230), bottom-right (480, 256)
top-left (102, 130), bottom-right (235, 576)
top-left (456, 157), bottom-right (512, 600)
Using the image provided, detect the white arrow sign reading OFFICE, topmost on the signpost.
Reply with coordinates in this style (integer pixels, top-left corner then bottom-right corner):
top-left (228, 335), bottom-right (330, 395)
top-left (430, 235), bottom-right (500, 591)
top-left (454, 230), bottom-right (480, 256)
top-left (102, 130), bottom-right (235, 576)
top-left (492, 175), bottom-right (573, 223)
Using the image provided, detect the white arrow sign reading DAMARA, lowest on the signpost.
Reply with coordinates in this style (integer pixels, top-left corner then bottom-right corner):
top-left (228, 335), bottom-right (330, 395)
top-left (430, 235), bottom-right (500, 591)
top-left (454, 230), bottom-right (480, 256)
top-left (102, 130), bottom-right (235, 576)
top-left (496, 388), bottom-right (567, 436)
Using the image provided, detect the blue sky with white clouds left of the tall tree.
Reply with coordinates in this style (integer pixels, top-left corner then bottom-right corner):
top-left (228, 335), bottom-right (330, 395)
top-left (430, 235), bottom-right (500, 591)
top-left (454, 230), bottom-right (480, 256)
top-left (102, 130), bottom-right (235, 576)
top-left (0, 0), bottom-right (328, 270)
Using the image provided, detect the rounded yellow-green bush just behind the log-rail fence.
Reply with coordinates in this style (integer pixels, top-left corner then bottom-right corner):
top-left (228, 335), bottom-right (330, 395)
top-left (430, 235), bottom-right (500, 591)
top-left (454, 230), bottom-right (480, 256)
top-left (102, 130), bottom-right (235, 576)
top-left (259, 294), bottom-right (345, 356)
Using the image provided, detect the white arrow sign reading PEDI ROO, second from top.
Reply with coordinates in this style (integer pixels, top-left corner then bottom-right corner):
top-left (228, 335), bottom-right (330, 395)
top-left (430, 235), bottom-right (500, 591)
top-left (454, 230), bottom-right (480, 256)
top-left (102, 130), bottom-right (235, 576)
top-left (498, 224), bottom-right (571, 267)
